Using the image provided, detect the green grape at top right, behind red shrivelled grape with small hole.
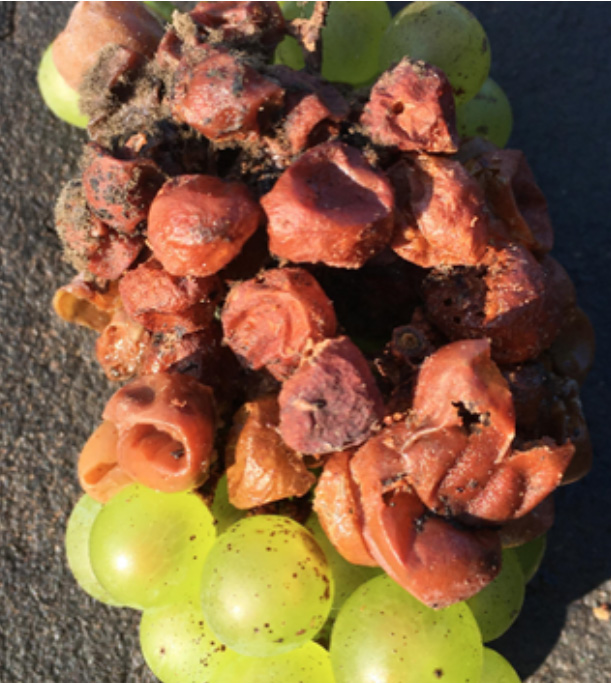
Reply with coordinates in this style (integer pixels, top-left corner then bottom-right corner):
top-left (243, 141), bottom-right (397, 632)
top-left (380, 2), bottom-right (490, 104)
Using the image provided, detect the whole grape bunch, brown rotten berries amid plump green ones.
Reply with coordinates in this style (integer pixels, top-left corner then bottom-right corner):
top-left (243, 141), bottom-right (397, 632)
top-left (39, 2), bottom-right (594, 683)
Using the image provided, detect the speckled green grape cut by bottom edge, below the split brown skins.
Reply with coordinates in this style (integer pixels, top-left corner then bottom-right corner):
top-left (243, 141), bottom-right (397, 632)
top-left (330, 576), bottom-right (483, 683)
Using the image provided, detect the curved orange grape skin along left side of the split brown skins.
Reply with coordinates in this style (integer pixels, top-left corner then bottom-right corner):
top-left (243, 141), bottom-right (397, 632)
top-left (314, 451), bottom-right (378, 567)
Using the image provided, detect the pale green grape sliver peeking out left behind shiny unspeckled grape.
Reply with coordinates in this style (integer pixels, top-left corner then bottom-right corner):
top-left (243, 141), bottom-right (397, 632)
top-left (65, 494), bottom-right (121, 607)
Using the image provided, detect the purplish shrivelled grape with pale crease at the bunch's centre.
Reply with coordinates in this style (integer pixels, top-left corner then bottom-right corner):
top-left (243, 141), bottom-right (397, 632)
top-left (279, 337), bottom-right (384, 453)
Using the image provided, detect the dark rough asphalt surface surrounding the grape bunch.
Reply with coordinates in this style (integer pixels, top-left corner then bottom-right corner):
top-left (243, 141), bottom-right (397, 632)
top-left (0, 2), bottom-right (611, 683)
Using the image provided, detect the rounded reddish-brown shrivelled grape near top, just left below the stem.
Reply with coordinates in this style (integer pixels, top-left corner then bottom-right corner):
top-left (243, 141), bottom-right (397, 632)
top-left (170, 45), bottom-right (284, 141)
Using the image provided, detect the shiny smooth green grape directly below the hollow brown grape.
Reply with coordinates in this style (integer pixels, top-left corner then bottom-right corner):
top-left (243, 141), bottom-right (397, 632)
top-left (89, 485), bottom-right (215, 609)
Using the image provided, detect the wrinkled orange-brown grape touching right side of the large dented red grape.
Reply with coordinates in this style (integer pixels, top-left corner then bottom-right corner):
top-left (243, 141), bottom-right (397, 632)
top-left (388, 154), bottom-right (488, 268)
